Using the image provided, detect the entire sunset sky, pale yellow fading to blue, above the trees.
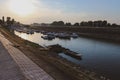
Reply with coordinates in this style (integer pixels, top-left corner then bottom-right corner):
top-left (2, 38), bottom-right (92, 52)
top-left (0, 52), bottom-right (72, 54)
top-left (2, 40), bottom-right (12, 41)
top-left (0, 0), bottom-right (120, 24)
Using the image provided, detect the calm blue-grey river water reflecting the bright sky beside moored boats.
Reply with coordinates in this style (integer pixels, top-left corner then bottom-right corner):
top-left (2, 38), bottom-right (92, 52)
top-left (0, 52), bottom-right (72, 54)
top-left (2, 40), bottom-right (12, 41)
top-left (15, 31), bottom-right (120, 80)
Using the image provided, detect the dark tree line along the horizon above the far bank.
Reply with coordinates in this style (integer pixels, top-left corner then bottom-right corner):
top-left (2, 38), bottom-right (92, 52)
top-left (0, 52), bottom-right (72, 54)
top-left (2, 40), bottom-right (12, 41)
top-left (51, 20), bottom-right (120, 27)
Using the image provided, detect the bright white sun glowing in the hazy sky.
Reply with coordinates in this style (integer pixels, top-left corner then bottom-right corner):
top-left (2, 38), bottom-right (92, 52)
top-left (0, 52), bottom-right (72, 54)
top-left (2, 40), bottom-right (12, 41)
top-left (9, 0), bottom-right (35, 16)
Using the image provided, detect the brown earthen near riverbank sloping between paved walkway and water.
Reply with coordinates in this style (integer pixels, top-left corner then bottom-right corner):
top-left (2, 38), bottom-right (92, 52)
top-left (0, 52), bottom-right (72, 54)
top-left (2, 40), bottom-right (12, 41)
top-left (1, 26), bottom-right (108, 80)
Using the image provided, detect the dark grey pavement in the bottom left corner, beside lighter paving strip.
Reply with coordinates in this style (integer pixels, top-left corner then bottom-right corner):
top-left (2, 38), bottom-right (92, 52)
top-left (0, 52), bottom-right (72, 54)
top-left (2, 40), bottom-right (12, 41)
top-left (0, 42), bottom-right (25, 80)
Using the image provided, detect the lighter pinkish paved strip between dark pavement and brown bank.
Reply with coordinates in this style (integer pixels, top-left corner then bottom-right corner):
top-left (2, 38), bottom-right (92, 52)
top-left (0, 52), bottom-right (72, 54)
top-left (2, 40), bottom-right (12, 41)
top-left (0, 33), bottom-right (54, 80)
